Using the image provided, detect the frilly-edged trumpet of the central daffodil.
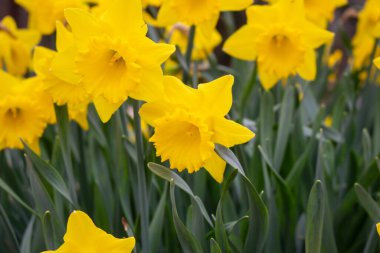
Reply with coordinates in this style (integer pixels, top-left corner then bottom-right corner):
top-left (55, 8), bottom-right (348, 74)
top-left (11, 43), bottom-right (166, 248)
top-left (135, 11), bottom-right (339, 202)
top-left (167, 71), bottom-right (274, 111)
top-left (150, 111), bottom-right (214, 173)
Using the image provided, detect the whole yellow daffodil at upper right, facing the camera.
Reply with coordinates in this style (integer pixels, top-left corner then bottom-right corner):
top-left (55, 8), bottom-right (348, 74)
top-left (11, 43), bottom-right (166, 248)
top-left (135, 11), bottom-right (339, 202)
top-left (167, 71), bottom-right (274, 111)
top-left (224, 0), bottom-right (334, 90)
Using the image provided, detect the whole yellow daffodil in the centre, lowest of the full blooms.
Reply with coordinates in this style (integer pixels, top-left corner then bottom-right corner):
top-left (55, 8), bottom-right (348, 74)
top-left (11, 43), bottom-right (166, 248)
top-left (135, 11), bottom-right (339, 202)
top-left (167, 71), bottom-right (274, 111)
top-left (140, 76), bottom-right (254, 183)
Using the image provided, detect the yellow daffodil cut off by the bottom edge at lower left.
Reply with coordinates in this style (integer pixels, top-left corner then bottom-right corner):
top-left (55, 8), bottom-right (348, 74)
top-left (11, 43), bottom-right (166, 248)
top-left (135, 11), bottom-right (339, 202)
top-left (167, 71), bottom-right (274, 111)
top-left (43, 211), bottom-right (135, 253)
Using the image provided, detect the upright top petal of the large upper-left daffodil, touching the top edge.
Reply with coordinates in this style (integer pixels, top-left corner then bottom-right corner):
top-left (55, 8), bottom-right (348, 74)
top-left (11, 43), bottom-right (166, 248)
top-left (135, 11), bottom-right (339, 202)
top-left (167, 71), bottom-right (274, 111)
top-left (102, 0), bottom-right (148, 38)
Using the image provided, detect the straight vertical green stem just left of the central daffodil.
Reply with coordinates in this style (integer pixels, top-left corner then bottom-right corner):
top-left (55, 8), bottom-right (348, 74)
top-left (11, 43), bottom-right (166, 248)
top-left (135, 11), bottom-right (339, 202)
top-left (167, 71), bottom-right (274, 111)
top-left (133, 101), bottom-right (151, 252)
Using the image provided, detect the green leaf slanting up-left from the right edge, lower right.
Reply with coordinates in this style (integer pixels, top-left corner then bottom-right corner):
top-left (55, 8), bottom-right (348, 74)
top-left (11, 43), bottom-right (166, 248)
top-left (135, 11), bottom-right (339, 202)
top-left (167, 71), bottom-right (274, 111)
top-left (355, 183), bottom-right (380, 223)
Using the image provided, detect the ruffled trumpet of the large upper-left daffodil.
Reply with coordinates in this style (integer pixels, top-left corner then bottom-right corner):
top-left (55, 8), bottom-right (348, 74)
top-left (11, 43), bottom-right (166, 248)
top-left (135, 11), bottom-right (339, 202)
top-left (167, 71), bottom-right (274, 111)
top-left (76, 37), bottom-right (141, 103)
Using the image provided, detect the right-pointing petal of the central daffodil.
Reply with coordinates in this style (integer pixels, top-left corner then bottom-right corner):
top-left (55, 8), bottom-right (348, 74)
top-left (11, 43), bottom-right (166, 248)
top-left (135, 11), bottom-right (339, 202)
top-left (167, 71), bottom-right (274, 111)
top-left (213, 117), bottom-right (255, 147)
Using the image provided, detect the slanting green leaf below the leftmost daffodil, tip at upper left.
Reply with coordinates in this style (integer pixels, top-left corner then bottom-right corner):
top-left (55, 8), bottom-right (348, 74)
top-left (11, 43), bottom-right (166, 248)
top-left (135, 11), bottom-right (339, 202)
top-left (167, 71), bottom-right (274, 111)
top-left (23, 142), bottom-right (73, 204)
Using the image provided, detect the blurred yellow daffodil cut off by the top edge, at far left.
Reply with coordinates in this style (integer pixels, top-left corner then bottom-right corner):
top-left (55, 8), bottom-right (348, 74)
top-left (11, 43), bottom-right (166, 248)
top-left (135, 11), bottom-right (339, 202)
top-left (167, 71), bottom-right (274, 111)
top-left (16, 0), bottom-right (90, 34)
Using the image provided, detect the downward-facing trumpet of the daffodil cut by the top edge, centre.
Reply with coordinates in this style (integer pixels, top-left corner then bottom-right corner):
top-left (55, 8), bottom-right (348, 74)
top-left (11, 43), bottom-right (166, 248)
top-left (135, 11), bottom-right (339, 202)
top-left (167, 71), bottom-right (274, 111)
top-left (172, 0), bottom-right (220, 25)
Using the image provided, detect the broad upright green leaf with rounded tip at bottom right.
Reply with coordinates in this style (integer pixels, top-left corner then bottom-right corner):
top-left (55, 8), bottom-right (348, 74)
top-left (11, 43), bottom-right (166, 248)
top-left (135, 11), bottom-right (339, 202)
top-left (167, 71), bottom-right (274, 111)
top-left (305, 180), bottom-right (325, 253)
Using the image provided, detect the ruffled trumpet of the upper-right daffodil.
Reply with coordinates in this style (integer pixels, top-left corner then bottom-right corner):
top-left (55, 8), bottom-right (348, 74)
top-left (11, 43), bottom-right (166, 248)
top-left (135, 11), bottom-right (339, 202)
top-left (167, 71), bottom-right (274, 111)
top-left (257, 26), bottom-right (305, 78)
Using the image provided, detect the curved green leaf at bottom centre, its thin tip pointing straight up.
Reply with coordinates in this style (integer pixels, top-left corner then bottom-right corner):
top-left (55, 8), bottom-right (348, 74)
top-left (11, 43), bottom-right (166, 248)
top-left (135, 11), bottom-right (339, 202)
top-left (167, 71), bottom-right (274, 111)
top-left (170, 181), bottom-right (203, 253)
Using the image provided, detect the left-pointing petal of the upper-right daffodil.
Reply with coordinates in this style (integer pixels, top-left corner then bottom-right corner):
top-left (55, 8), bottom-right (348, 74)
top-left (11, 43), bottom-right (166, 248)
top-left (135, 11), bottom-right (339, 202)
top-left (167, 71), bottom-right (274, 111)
top-left (223, 25), bottom-right (261, 61)
